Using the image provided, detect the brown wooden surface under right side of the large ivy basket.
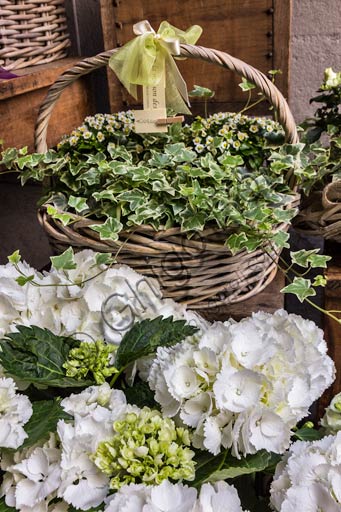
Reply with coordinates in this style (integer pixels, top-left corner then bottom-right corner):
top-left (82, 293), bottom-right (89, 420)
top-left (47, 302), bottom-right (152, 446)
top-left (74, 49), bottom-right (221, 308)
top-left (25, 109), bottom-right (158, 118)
top-left (200, 272), bottom-right (285, 322)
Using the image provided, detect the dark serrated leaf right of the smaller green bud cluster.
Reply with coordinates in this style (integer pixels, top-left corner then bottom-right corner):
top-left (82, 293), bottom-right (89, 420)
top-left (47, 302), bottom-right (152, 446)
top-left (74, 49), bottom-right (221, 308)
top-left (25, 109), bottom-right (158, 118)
top-left (115, 316), bottom-right (198, 370)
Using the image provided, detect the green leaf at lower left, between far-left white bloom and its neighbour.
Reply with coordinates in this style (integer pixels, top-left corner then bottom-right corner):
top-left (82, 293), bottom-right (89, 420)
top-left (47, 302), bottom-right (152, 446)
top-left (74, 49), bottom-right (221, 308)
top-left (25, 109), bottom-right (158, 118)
top-left (20, 400), bottom-right (71, 449)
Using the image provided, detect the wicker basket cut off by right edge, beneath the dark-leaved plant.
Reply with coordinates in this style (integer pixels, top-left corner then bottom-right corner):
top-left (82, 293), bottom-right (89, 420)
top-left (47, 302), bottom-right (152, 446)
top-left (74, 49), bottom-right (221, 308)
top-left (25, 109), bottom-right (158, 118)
top-left (293, 180), bottom-right (341, 243)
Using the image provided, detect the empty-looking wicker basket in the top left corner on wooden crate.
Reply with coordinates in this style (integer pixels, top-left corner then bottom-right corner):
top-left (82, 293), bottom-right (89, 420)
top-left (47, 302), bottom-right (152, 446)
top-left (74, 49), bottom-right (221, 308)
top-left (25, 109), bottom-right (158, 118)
top-left (0, 0), bottom-right (70, 69)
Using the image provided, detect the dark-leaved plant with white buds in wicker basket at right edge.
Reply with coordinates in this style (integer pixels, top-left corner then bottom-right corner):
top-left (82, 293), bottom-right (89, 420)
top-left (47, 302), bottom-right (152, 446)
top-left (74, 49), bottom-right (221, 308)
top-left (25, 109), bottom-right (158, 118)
top-left (293, 68), bottom-right (341, 242)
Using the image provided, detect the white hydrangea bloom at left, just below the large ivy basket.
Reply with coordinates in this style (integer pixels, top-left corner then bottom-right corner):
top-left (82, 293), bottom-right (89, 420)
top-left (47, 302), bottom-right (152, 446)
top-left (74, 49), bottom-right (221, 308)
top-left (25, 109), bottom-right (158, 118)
top-left (0, 250), bottom-right (207, 343)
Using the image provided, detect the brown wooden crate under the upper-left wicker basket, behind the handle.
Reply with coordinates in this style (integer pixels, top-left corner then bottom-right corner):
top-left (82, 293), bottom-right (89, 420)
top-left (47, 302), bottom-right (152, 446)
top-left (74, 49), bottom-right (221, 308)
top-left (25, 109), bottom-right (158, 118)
top-left (0, 57), bottom-right (95, 151)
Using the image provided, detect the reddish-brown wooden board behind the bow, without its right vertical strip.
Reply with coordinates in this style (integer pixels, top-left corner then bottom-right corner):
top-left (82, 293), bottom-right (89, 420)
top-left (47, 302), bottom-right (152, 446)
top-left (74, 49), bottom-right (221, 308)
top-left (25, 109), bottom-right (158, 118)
top-left (105, 0), bottom-right (274, 112)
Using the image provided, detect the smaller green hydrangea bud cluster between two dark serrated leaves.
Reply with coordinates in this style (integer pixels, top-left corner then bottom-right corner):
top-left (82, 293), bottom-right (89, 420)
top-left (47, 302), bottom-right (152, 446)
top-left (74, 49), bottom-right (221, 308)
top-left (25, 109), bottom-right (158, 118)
top-left (63, 340), bottom-right (118, 384)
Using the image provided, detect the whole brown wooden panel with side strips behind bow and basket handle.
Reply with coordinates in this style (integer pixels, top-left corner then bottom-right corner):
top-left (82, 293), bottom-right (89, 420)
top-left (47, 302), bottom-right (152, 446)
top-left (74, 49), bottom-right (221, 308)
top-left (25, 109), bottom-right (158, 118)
top-left (101, 0), bottom-right (291, 113)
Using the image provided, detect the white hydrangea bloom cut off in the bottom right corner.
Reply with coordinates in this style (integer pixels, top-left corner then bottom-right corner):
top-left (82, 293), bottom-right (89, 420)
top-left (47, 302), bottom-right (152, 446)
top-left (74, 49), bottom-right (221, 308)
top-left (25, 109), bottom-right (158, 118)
top-left (271, 432), bottom-right (341, 512)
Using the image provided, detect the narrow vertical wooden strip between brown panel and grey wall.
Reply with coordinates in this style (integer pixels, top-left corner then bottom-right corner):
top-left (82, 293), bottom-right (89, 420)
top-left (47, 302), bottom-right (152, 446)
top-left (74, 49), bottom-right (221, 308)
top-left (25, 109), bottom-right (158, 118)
top-left (272, 0), bottom-right (292, 99)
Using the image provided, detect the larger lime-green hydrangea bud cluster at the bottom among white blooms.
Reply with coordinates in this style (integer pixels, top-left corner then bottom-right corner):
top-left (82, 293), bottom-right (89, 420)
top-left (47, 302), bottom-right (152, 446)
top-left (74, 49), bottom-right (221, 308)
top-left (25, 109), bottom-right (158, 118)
top-left (91, 407), bottom-right (195, 490)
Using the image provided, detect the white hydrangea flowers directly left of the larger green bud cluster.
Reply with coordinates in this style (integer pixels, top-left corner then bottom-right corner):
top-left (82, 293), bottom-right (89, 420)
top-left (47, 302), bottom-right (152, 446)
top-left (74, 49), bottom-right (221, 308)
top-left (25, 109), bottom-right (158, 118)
top-left (0, 383), bottom-right (128, 512)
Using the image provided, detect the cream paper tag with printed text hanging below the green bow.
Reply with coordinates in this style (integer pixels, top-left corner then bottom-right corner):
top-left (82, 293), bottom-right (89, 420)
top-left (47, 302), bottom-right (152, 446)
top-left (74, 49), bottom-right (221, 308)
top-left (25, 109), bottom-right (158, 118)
top-left (134, 61), bottom-right (168, 133)
